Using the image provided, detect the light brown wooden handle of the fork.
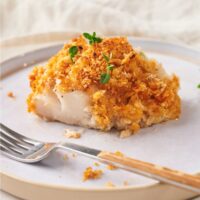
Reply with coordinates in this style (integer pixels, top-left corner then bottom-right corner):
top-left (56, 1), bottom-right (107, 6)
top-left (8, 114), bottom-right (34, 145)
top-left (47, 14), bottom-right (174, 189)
top-left (98, 151), bottom-right (200, 194)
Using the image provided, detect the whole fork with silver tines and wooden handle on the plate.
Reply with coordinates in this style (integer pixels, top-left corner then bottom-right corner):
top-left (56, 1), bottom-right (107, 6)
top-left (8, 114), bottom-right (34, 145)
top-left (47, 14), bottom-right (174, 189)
top-left (0, 123), bottom-right (200, 194)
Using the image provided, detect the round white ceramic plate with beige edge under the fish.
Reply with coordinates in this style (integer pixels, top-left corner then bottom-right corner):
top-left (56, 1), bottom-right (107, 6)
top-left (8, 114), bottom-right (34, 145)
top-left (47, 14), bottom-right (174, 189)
top-left (1, 38), bottom-right (200, 200)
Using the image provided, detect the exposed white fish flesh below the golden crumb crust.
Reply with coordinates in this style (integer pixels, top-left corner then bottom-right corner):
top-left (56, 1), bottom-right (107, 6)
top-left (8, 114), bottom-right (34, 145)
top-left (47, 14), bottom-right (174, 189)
top-left (35, 91), bottom-right (95, 128)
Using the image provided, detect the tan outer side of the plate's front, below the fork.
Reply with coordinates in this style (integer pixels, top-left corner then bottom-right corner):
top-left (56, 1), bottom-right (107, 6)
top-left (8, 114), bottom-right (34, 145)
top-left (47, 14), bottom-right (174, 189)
top-left (0, 170), bottom-right (195, 200)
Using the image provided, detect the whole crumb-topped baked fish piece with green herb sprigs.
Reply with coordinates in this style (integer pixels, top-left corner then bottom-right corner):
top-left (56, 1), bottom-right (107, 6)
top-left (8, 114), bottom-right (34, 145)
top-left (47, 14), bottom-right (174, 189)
top-left (27, 33), bottom-right (180, 137)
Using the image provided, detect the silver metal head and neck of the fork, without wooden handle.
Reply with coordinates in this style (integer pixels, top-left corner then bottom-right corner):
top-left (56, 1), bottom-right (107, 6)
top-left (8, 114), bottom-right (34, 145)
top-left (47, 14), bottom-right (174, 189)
top-left (0, 123), bottom-right (100, 163)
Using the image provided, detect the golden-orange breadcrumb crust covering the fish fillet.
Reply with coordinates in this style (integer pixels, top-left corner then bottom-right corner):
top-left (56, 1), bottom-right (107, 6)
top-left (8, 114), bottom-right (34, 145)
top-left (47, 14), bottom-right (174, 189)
top-left (27, 36), bottom-right (180, 136)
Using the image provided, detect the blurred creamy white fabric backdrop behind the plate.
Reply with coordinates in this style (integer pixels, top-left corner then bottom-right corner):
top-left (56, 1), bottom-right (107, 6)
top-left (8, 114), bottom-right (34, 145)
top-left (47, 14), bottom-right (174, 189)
top-left (0, 0), bottom-right (200, 49)
